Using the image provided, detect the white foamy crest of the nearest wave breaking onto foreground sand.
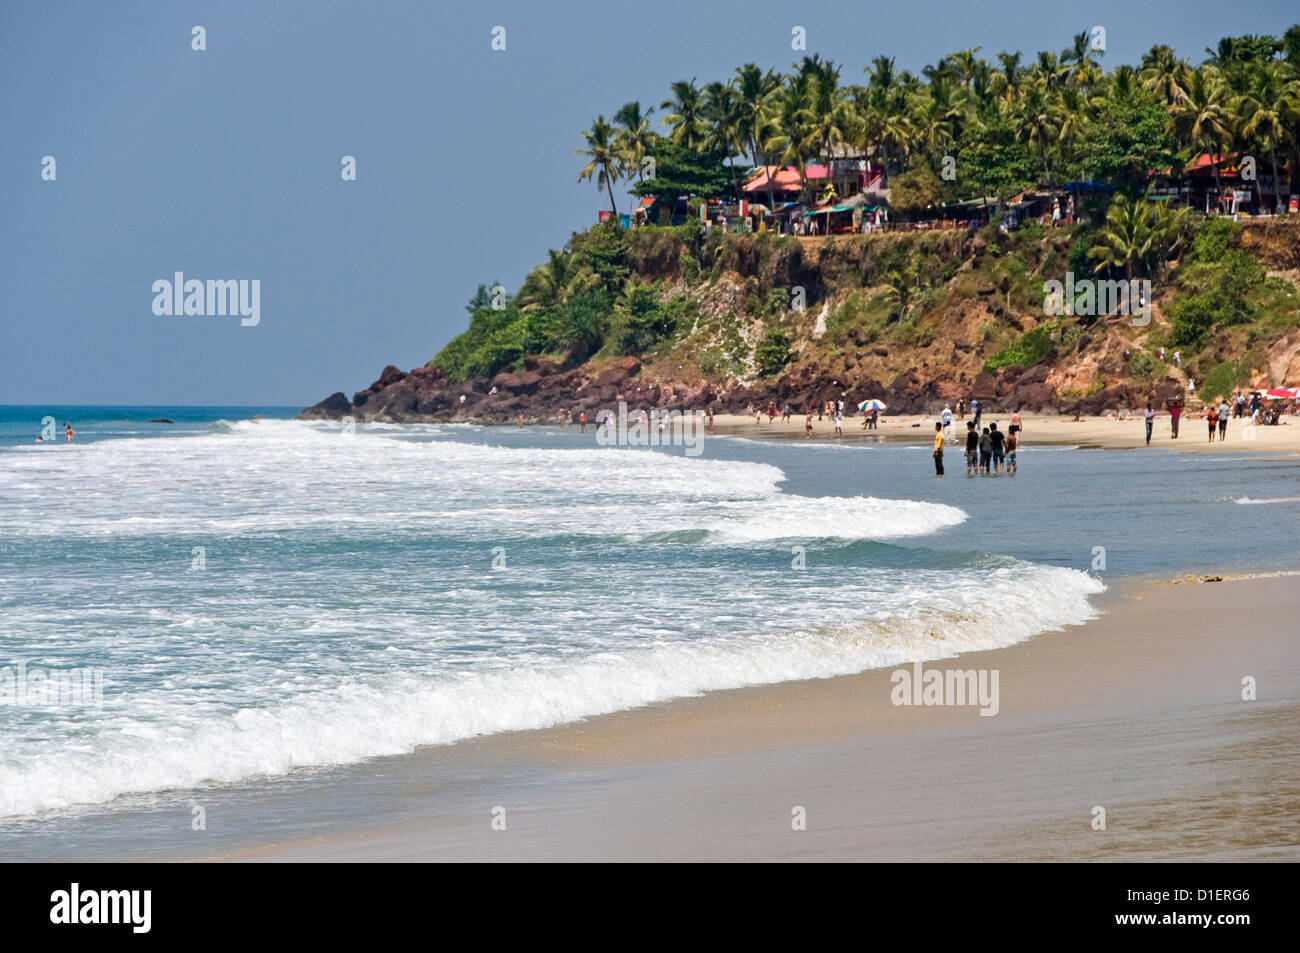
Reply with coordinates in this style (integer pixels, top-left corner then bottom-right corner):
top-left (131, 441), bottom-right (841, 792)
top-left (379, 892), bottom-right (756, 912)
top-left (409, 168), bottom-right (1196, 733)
top-left (0, 564), bottom-right (1102, 816)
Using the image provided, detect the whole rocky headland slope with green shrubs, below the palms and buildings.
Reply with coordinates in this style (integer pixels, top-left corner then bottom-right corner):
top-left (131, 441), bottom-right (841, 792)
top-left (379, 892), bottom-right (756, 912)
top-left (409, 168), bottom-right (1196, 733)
top-left (299, 221), bottom-right (1300, 423)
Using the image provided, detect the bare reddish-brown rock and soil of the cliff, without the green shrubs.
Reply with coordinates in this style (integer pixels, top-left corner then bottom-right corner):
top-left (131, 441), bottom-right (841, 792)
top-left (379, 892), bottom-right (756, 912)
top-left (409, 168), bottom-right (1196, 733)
top-left (300, 221), bottom-right (1300, 423)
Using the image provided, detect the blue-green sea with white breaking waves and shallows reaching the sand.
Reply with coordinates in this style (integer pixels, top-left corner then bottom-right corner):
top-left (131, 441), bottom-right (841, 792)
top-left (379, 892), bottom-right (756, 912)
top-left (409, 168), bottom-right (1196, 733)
top-left (0, 407), bottom-right (1300, 859)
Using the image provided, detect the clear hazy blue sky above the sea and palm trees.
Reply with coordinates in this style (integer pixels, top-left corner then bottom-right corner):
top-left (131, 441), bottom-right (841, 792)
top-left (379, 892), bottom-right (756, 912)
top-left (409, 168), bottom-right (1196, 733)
top-left (0, 0), bottom-right (1300, 407)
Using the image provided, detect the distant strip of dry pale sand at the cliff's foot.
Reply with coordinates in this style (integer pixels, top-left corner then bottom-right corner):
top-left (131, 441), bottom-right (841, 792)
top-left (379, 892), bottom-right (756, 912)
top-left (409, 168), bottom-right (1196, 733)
top-left (714, 411), bottom-right (1300, 454)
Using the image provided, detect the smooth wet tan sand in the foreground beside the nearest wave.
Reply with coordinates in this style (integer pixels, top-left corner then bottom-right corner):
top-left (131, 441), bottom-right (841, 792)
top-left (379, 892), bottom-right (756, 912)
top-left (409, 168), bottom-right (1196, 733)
top-left (220, 575), bottom-right (1300, 862)
